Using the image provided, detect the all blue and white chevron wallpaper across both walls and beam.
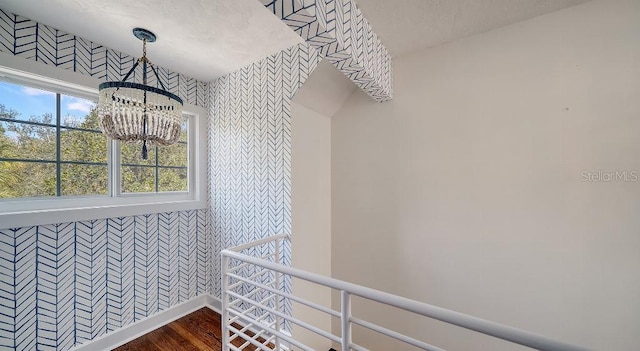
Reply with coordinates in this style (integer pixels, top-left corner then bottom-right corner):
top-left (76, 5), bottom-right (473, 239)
top-left (0, 0), bottom-right (392, 351)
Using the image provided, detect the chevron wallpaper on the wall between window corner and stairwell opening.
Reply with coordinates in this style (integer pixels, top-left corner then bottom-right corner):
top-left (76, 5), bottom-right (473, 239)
top-left (209, 44), bottom-right (321, 328)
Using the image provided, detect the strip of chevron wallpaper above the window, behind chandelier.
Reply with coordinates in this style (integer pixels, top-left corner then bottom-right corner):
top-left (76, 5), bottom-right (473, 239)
top-left (0, 9), bottom-right (209, 107)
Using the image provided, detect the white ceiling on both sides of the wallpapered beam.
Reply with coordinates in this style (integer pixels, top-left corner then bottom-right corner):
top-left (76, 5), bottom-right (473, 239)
top-left (0, 0), bottom-right (587, 84)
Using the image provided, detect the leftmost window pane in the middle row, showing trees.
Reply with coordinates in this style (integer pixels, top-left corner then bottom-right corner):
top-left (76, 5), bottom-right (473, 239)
top-left (0, 122), bottom-right (56, 161)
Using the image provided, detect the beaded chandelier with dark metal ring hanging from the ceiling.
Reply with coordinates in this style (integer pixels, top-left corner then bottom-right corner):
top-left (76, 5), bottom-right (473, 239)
top-left (98, 28), bottom-right (183, 160)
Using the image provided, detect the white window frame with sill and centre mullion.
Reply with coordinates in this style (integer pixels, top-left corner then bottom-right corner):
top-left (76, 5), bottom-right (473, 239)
top-left (0, 59), bottom-right (207, 229)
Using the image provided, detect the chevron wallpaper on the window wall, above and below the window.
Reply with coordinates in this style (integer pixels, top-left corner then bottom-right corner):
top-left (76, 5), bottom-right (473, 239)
top-left (0, 9), bottom-right (213, 351)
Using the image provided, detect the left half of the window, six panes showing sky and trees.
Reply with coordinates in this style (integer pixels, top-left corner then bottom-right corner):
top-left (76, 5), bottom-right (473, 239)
top-left (0, 81), bottom-right (109, 198)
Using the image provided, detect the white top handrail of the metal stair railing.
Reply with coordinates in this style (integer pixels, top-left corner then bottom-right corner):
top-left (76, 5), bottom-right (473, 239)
top-left (221, 234), bottom-right (588, 351)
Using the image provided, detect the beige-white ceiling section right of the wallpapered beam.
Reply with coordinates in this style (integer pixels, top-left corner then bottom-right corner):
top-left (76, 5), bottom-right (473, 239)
top-left (355, 0), bottom-right (589, 57)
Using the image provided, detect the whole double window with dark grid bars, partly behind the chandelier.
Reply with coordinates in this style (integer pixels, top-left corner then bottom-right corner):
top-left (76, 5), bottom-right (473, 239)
top-left (0, 72), bottom-right (196, 212)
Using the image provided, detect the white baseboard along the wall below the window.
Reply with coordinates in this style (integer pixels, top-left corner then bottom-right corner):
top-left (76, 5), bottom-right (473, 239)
top-left (69, 295), bottom-right (221, 351)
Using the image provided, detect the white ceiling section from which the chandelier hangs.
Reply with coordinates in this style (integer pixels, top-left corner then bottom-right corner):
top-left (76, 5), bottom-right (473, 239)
top-left (0, 0), bottom-right (302, 81)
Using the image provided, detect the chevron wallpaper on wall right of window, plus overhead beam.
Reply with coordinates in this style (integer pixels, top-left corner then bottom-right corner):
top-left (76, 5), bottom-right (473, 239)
top-left (209, 0), bottom-right (392, 284)
